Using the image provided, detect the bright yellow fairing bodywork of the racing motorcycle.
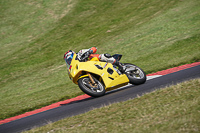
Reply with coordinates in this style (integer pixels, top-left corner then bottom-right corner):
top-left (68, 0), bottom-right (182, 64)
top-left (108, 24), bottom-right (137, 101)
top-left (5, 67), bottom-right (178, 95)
top-left (68, 55), bottom-right (129, 91)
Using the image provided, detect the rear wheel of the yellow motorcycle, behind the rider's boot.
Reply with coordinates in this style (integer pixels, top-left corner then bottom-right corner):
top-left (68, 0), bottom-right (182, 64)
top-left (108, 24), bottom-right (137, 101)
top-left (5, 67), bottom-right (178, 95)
top-left (124, 63), bottom-right (146, 85)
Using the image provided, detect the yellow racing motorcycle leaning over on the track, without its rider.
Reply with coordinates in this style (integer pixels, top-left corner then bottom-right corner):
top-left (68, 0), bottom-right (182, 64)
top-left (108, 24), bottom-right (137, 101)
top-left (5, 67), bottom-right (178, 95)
top-left (66, 53), bottom-right (146, 97)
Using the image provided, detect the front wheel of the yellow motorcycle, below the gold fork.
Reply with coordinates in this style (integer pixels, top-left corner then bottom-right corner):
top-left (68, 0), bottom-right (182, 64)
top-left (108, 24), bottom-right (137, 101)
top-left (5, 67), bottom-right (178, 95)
top-left (78, 77), bottom-right (106, 97)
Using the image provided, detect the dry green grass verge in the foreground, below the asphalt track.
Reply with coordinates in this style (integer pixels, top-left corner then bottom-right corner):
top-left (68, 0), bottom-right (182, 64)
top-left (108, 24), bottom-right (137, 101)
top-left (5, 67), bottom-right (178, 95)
top-left (23, 79), bottom-right (200, 133)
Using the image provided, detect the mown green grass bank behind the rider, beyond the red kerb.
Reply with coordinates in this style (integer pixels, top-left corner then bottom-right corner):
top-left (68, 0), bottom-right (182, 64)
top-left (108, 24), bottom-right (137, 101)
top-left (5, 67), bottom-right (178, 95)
top-left (0, 0), bottom-right (200, 119)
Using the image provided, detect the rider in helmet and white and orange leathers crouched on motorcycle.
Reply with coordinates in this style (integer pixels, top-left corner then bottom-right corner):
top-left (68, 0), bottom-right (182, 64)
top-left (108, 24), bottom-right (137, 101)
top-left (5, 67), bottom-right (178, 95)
top-left (64, 47), bottom-right (125, 73)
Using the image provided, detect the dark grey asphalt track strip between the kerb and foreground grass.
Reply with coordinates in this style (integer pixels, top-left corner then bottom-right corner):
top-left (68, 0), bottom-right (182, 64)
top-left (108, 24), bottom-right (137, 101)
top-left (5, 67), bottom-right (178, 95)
top-left (0, 65), bottom-right (200, 133)
